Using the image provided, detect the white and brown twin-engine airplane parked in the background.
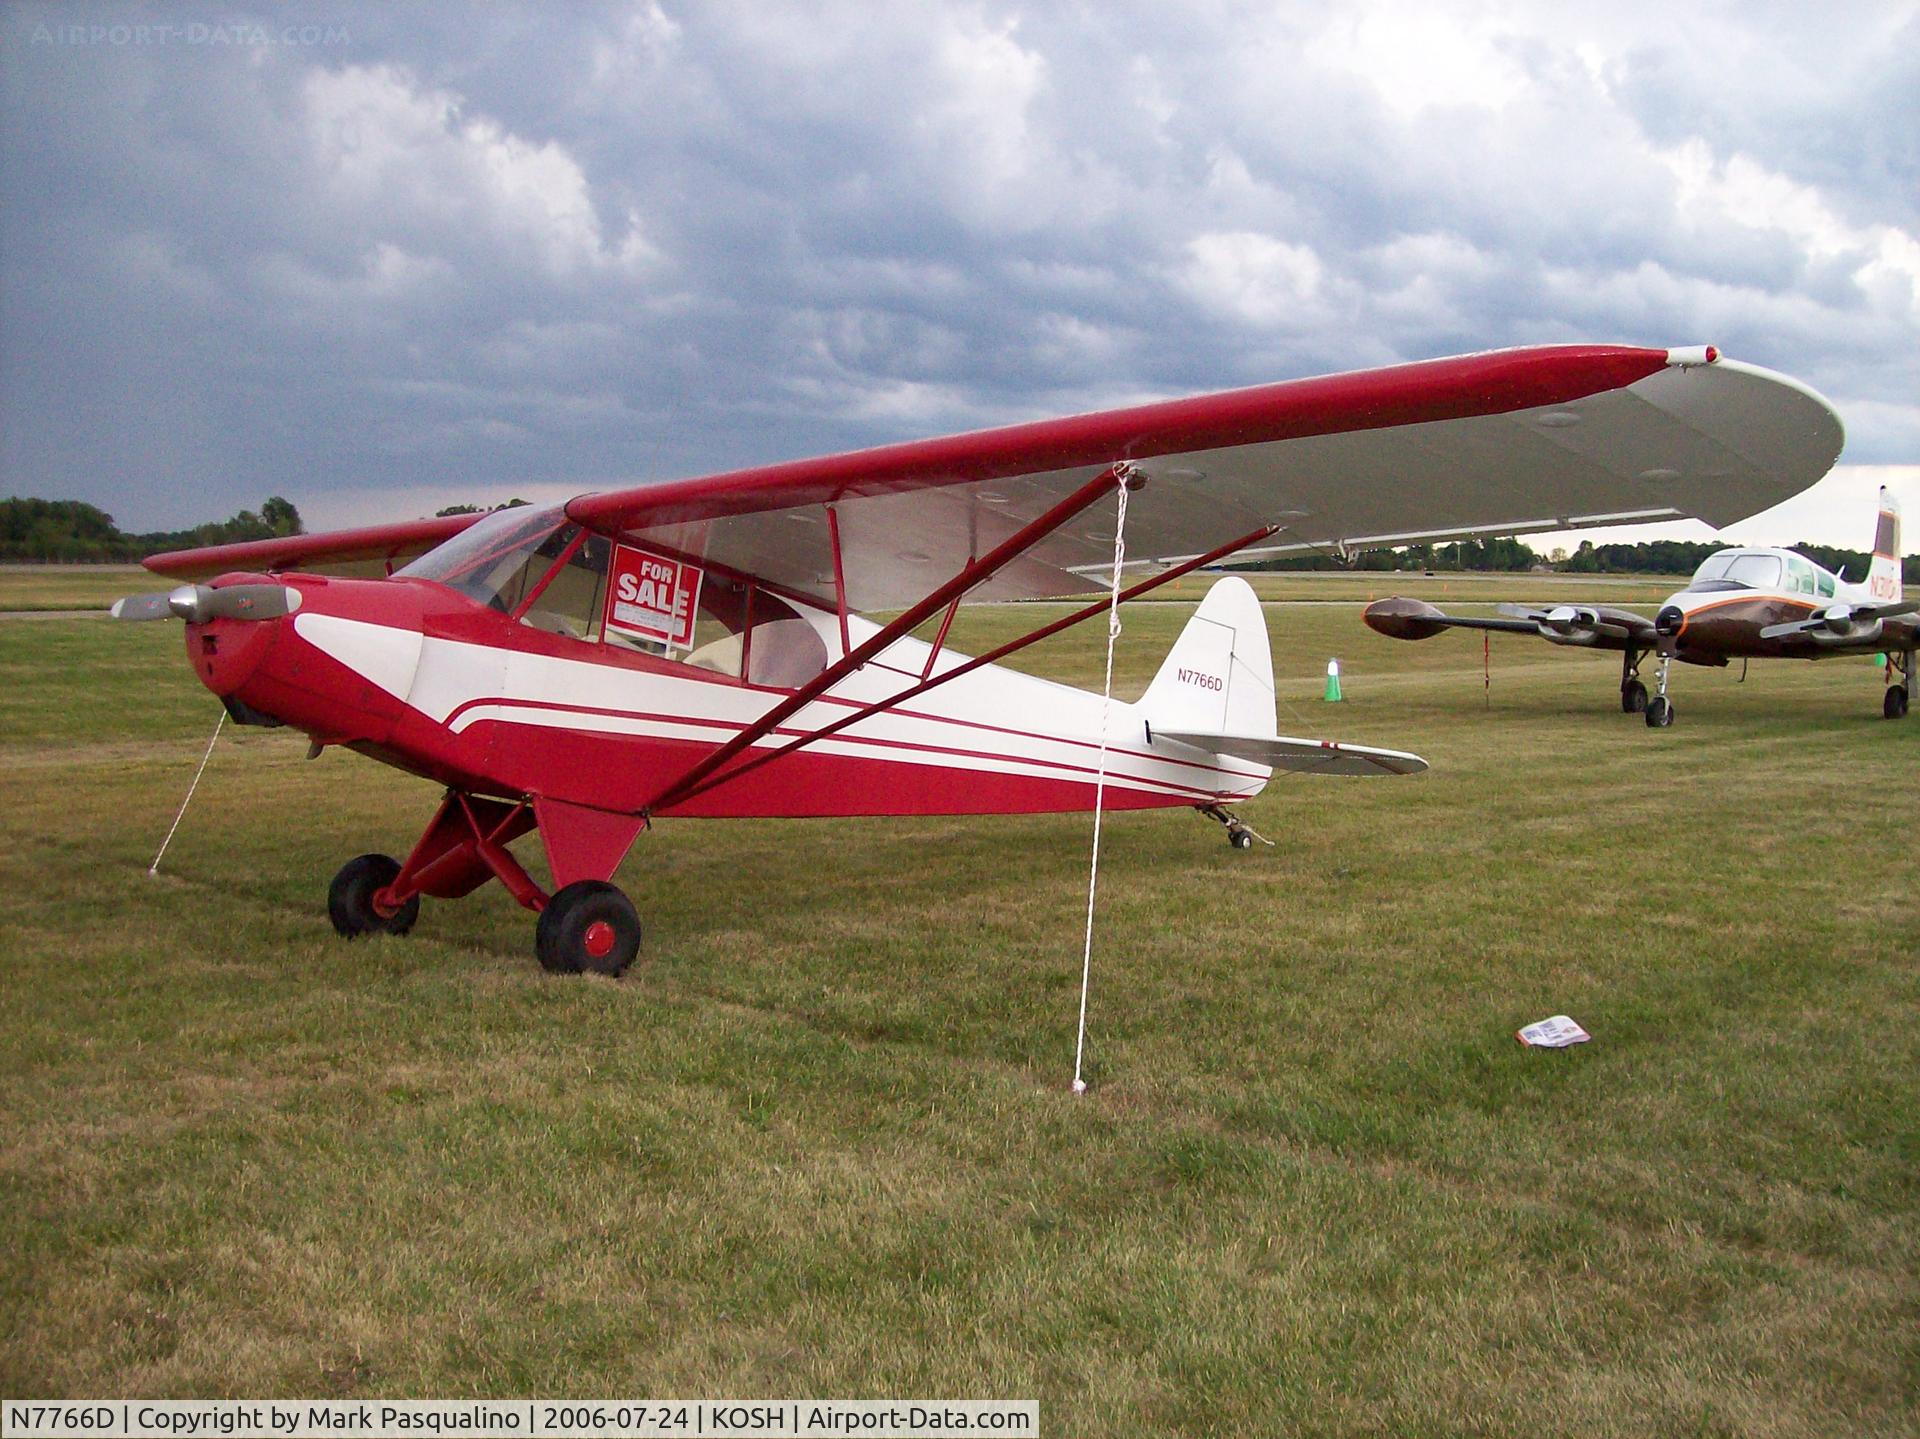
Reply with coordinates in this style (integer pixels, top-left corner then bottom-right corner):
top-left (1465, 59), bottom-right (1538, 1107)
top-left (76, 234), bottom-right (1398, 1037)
top-left (1365, 488), bottom-right (1920, 728)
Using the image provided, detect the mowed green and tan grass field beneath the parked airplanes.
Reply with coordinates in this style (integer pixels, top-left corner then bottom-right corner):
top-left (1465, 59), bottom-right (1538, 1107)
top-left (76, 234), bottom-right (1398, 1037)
top-left (0, 605), bottom-right (1920, 1435)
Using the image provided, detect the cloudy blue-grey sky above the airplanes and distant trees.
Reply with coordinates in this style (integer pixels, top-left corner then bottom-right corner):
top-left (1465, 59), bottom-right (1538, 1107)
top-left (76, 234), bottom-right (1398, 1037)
top-left (0, 0), bottom-right (1920, 549)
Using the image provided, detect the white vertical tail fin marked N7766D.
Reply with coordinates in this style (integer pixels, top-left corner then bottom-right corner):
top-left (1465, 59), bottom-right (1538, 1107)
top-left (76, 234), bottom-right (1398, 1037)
top-left (1139, 576), bottom-right (1277, 738)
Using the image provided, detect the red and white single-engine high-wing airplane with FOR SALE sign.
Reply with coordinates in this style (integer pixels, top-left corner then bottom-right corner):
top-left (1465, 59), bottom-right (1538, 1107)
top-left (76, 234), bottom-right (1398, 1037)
top-left (115, 346), bottom-right (1841, 974)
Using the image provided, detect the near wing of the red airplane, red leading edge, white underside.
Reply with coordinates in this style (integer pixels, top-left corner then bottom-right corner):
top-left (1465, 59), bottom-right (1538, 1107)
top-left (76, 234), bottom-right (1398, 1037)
top-left (566, 346), bottom-right (1841, 611)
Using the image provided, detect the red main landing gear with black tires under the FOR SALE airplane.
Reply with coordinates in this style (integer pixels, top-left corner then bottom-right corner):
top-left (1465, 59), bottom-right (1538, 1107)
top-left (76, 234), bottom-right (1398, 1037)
top-left (326, 790), bottom-right (647, 976)
